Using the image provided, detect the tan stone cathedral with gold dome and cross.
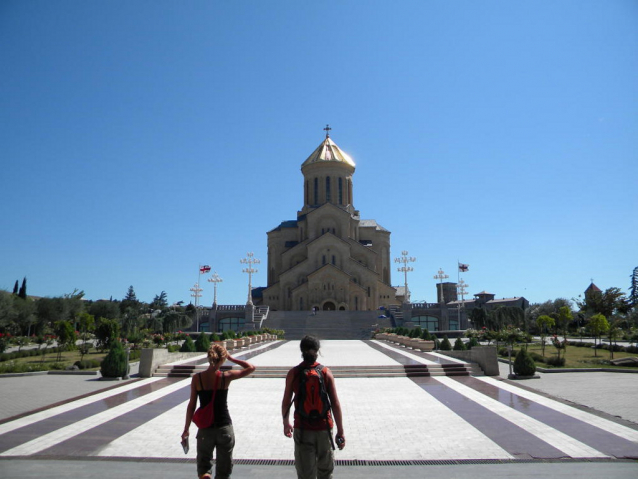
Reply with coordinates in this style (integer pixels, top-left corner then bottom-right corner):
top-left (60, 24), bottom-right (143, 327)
top-left (259, 127), bottom-right (397, 311)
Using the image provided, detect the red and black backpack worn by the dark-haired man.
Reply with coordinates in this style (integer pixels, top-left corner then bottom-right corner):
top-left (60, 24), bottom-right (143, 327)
top-left (295, 364), bottom-right (332, 421)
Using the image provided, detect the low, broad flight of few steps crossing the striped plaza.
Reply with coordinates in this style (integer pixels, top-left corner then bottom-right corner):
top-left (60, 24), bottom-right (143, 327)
top-left (153, 363), bottom-right (483, 378)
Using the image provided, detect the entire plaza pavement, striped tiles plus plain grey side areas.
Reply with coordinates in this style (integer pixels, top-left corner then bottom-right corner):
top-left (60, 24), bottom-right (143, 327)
top-left (0, 341), bottom-right (638, 479)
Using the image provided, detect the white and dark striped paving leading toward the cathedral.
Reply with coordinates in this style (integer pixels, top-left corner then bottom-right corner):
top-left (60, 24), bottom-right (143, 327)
top-left (0, 341), bottom-right (638, 466)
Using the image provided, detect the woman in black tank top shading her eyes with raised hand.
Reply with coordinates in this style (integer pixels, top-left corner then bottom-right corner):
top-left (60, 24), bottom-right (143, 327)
top-left (182, 343), bottom-right (255, 479)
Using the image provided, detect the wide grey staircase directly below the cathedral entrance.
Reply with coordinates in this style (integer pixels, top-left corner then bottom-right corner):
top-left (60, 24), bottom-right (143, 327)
top-left (263, 311), bottom-right (392, 339)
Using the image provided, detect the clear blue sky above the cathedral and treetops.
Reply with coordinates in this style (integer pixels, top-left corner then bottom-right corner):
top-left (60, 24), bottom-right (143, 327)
top-left (0, 0), bottom-right (638, 304)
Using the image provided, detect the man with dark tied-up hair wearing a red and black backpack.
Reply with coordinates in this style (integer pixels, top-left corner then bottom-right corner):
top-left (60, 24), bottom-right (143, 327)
top-left (281, 336), bottom-right (346, 479)
